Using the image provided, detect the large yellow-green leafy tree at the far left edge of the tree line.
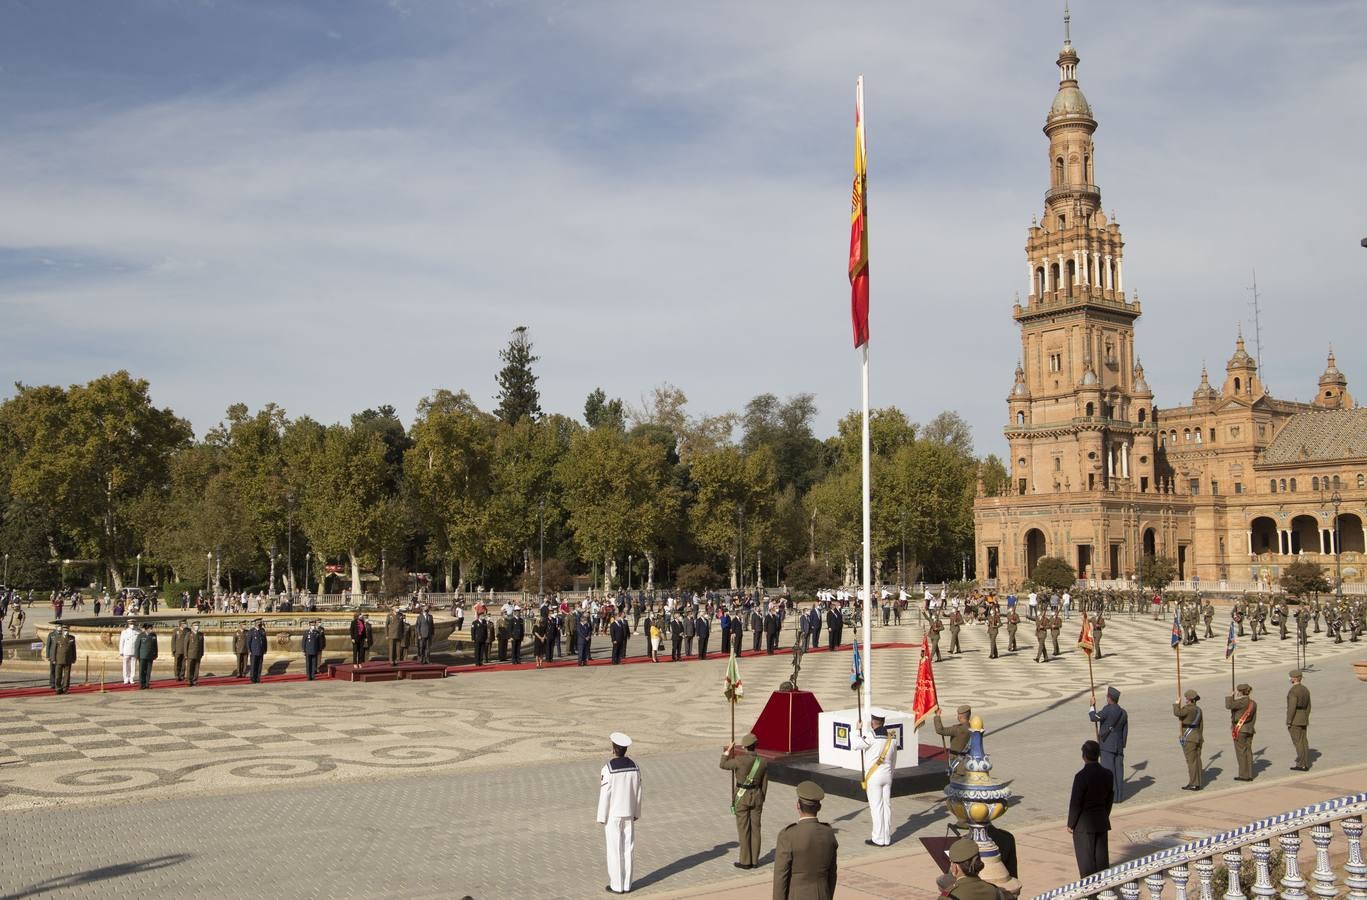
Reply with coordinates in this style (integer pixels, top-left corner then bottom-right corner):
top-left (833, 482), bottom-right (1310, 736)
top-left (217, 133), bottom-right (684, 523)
top-left (0, 371), bottom-right (191, 590)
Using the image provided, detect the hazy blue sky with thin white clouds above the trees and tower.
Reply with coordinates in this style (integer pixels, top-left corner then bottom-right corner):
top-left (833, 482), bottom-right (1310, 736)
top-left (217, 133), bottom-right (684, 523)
top-left (0, 0), bottom-right (1367, 451)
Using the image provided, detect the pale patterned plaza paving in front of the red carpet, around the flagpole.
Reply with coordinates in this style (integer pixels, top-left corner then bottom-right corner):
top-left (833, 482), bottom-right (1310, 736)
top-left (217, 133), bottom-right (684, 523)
top-left (0, 620), bottom-right (1364, 897)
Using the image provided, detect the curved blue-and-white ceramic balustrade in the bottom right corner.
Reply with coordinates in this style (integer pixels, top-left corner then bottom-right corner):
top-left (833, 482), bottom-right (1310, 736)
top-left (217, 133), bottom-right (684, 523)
top-left (1035, 793), bottom-right (1367, 900)
